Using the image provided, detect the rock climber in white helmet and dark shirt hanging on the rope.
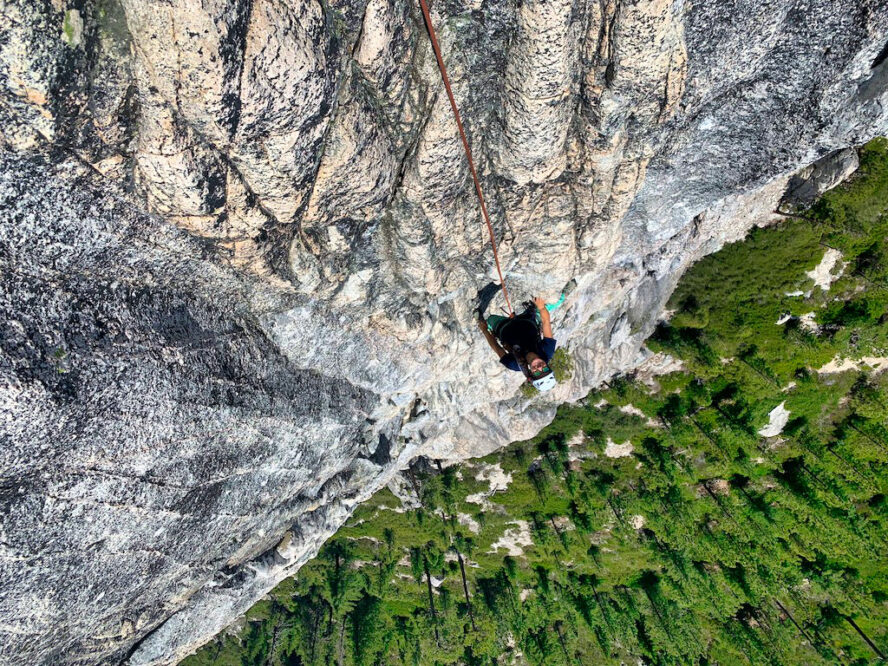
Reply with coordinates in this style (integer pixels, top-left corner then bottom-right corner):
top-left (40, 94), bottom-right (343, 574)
top-left (478, 298), bottom-right (558, 391)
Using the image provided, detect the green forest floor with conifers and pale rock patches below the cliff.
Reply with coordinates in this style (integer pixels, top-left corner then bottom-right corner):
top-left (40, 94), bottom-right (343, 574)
top-left (182, 140), bottom-right (888, 666)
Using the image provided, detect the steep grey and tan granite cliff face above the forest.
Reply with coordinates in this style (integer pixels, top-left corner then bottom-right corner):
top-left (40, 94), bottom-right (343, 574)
top-left (0, 0), bottom-right (888, 665)
